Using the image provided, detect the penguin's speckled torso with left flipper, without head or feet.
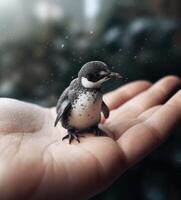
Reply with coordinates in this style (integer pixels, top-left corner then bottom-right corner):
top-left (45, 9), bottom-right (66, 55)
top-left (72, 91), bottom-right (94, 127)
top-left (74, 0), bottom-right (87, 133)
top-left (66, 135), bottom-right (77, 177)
top-left (55, 79), bottom-right (105, 130)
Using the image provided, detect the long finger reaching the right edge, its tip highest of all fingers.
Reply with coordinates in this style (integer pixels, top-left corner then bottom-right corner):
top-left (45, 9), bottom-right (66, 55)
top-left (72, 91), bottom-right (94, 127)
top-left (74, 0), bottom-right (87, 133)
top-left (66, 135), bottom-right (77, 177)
top-left (110, 76), bottom-right (181, 121)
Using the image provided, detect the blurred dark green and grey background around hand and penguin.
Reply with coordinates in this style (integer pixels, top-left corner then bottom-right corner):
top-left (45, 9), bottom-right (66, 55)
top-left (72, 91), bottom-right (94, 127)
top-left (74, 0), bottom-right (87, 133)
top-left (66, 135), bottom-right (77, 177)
top-left (0, 0), bottom-right (181, 200)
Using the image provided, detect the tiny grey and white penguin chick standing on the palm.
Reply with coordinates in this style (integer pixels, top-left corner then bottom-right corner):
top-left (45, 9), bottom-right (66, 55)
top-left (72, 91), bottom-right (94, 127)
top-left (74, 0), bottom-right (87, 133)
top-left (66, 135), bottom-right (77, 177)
top-left (54, 61), bottom-right (122, 143)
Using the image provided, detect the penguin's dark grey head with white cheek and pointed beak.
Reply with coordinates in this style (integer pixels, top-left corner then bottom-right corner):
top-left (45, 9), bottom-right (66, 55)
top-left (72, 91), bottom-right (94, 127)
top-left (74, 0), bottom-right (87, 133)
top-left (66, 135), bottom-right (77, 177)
top-left (78, 61), bottom-right (122, 88)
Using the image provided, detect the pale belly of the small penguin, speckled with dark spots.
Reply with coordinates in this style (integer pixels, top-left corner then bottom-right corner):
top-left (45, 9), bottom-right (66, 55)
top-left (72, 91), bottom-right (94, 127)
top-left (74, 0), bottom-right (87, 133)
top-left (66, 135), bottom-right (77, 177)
top-left (69, 93), bottom-right (102, 129)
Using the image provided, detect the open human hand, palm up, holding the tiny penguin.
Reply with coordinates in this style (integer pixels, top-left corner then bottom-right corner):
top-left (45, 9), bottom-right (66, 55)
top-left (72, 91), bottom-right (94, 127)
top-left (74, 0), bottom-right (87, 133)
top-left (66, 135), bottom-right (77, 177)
top-left (0, 76), bottom-right (181, 200)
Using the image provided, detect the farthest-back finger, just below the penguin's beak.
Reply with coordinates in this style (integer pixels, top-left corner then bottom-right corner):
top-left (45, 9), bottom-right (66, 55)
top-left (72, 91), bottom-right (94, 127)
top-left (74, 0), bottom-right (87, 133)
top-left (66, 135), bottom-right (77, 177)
top-left (104, 81), bottom-right (151, 110)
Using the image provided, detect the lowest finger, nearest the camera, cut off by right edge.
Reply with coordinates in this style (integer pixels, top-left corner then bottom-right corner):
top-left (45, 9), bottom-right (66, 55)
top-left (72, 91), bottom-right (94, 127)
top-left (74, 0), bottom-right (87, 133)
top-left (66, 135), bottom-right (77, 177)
top-left (117, 91), bottom-right (181, 166)
